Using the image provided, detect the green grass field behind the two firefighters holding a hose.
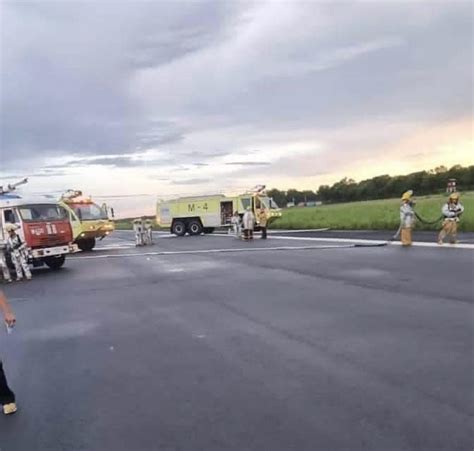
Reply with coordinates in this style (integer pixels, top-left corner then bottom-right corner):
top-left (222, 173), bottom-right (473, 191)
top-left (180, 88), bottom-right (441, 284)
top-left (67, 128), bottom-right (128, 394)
top-left (271, 192), bottom-right (474, 232)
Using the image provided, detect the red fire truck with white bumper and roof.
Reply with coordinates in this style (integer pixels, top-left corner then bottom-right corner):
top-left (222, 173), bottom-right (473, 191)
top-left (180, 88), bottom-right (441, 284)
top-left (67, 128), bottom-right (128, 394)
top-left (0, 193), bottom-right (78, 269)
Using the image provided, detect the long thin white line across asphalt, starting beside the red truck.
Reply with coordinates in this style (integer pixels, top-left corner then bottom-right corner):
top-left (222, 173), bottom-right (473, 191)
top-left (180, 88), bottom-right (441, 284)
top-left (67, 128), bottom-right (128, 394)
top-left (69, 244), bottom-right (355, 262)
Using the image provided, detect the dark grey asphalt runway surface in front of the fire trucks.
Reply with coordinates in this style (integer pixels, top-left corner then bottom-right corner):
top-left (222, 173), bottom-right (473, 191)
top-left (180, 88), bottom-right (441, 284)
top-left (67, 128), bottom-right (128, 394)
top-left (0, 232), bottom-right (474, 451)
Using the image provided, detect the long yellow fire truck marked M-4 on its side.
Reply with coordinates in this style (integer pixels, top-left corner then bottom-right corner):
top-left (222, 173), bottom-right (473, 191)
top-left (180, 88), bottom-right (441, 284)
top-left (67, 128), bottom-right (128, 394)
top-left (156, 186), bottom-right (281, 236)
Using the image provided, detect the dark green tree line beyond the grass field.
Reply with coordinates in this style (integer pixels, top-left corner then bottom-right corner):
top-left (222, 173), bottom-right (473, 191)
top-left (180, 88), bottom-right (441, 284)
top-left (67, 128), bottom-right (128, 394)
top-left (268, 165), bottom-right (474, 207)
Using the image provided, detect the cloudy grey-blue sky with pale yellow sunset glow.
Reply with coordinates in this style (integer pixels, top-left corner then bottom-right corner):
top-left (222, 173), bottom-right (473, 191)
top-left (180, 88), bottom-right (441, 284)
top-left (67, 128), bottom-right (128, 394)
top-left (0, 0), bottom-right (474, 214)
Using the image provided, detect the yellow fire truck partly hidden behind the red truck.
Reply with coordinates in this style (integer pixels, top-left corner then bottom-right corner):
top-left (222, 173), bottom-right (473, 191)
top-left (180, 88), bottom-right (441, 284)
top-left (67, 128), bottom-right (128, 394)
top-left (60, 190), bottom-right (115, 251)
